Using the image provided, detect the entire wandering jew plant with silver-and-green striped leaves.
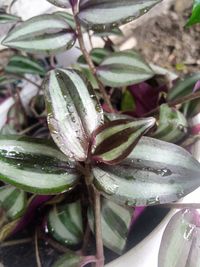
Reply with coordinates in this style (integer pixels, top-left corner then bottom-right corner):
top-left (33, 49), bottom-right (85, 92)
top-left (0, 0), bottom-right (200, 267)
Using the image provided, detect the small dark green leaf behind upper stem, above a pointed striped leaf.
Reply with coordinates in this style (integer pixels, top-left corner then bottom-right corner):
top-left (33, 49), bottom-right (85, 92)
top-left (77, 48), bottom-right (111, 65)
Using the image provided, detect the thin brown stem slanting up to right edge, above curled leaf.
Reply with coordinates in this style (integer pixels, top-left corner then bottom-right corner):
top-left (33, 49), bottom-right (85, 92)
top-left (145, 91), bottom-right (200, 116)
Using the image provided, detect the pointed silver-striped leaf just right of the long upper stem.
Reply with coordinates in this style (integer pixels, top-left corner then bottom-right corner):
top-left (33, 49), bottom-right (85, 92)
top-left (97, 50), bottom-right (154, 87)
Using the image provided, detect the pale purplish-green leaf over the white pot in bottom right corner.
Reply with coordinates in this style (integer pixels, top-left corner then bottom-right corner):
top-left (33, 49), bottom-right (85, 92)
top-left (158, 210), bottom-right (200, 267)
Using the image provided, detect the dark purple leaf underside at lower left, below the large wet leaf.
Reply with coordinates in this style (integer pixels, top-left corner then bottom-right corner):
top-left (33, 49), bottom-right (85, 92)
top-left (13, 195), bottom-right (52, 234)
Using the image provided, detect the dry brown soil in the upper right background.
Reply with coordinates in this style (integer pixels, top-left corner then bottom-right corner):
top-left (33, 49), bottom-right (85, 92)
top-left (133, 0), bottom-right (200, 76)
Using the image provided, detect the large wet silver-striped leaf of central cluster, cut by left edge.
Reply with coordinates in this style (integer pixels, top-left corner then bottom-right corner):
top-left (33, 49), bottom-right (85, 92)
top-left (0, 136), bottom-right (79, 194)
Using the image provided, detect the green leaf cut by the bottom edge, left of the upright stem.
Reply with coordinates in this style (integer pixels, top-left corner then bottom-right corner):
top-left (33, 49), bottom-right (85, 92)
top-left (52, 251), bottom-right (83, 267)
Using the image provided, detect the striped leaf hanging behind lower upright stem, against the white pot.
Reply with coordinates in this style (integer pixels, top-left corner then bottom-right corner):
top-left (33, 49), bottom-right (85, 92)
top-left (88, 198), bottom-right (133, 255)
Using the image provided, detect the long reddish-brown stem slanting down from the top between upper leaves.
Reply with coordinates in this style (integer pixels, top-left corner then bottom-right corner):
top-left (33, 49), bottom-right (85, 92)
top-left (73, 6), bottom-right (114, 112)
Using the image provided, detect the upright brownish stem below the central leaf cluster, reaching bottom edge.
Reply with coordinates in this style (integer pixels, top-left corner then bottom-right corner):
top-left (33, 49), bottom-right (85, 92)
top-left (93, 187), bottom-right (104, 267)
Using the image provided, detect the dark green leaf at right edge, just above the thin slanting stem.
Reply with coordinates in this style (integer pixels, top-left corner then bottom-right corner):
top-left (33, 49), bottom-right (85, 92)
top-left (167, 73), bottom-right (200, 101)
